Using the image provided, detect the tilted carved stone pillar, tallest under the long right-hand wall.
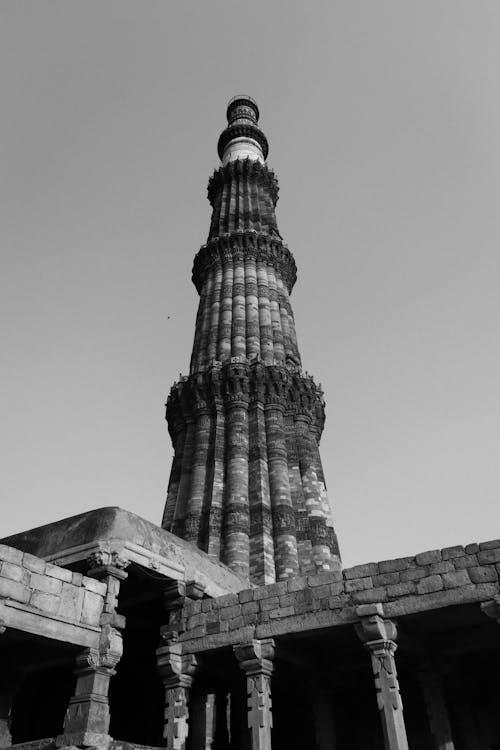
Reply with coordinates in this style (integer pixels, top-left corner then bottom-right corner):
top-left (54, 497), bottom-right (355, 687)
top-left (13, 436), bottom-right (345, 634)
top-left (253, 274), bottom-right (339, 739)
top-left (355, 604), bottom-right (408, 750)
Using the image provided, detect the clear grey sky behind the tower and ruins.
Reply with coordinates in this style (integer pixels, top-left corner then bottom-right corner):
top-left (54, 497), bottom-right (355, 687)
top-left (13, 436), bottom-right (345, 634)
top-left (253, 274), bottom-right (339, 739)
top-left (0, 0), bottom-right (500, 565)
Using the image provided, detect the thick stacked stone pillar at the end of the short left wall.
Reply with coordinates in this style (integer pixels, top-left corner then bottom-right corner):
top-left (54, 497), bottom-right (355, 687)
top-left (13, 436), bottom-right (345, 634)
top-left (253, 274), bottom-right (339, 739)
top-left (56, 551), bottom-right (129, 747)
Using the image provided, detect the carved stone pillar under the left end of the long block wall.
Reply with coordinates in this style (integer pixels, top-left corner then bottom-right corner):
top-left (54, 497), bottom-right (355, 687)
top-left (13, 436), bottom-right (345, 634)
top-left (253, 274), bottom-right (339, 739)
top-left (156, 639), bottom-right (197, 750)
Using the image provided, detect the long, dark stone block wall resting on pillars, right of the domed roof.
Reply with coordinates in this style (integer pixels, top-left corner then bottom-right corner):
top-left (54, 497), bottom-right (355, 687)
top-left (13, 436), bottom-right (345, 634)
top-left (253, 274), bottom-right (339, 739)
top-left (168, 540), bottom-right (500, 650)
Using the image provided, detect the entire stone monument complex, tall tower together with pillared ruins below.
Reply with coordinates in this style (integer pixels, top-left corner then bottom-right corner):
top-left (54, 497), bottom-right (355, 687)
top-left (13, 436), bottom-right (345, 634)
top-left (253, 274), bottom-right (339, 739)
top-left (0, 97), bottom-right (500, 750)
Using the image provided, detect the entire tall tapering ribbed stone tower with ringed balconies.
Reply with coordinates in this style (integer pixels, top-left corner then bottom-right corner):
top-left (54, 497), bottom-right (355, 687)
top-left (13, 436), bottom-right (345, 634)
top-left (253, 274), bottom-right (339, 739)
top-left (162, 96), bottom-right (340, 584)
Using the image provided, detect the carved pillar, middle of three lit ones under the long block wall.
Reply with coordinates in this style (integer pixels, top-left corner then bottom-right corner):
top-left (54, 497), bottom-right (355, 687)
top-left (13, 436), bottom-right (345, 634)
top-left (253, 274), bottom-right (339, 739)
top-left (234, 638), bottom-right (274, 750)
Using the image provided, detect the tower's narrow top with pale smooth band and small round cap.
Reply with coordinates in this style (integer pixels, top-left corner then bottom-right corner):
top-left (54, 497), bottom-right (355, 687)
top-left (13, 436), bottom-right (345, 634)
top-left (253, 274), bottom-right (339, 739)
top-left (217, 94), bottom-right (269, 166)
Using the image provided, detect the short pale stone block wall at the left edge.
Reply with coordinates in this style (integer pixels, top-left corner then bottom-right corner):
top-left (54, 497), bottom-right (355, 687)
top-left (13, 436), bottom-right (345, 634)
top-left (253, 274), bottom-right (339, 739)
top-left (0, 544), bottom-right (106, 627)
